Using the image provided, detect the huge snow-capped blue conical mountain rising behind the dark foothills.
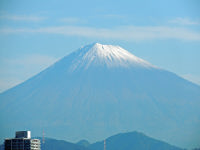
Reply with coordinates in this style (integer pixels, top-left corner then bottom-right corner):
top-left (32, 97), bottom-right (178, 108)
top-left (0, 43), bottom-right (200, 147)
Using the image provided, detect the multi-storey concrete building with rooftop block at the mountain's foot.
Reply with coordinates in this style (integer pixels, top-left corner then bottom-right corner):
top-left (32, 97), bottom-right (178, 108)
top-left (4, 131), bottom-right (41, 150)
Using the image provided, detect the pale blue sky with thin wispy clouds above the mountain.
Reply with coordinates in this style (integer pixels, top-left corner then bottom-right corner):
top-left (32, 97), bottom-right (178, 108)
top-left (0, 0), bottom-right (200, 92)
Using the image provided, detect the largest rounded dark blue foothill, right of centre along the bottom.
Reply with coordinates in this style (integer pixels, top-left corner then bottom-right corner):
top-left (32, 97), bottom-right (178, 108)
top-left (89, 132), bottom-right (182, 150)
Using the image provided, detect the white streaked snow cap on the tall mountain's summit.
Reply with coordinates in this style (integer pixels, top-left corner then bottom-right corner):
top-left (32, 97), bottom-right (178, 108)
top-left (71, 43), bottom-right (153, 71)
